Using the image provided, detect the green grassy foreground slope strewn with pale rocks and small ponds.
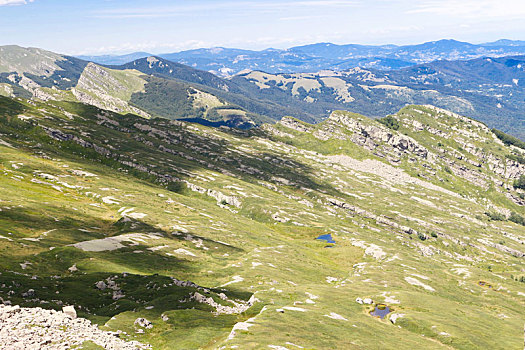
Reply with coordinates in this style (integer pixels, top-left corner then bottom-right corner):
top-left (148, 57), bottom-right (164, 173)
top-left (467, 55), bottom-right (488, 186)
top-left (0, 97), bottom-right (525, 349)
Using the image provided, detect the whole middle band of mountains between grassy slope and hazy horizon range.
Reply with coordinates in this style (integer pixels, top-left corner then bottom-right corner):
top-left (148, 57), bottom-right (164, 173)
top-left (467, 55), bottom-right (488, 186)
top-left (0, 41), bottom-right (525, 140)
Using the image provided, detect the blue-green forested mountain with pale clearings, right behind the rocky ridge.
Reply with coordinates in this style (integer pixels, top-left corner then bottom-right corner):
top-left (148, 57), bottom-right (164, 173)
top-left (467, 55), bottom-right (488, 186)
top-left (231, 56), bottom-right (525, 139)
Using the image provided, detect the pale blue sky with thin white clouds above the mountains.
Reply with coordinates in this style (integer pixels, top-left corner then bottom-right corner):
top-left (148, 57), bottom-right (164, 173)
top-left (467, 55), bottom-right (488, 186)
top-left (0, 0), bottom-right (525, 55)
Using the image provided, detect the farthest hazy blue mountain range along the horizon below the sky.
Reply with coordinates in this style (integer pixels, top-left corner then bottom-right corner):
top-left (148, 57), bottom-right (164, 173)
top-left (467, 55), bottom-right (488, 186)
top-left (79, 39), bottom-right (525, 76)
